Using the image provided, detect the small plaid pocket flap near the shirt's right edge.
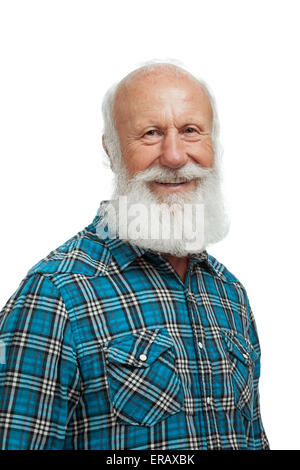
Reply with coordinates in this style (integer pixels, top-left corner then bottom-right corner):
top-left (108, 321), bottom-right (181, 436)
top-left (221, 329), bottom-right (258, 365)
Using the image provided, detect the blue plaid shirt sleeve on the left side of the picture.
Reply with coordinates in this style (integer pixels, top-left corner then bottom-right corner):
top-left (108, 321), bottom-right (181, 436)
top-left (0, 273), bottom-right (81, 450)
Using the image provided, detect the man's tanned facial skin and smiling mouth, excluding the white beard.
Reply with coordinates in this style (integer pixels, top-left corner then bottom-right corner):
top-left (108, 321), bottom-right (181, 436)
top-left (114, 74), bottom-right (214, 198)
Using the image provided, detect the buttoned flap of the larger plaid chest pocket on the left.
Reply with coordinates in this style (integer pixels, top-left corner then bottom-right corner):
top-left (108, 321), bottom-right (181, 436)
top-left (104, 328), bottom-right (173, 367)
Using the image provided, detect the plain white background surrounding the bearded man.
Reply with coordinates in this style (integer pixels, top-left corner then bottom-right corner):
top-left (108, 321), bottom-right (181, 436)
top-left (0, 0), bottom-right (300, 450)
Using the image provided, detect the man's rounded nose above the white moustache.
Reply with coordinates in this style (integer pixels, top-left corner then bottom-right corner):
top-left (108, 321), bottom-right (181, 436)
top-left (159, 132), bottom-right (188, 168)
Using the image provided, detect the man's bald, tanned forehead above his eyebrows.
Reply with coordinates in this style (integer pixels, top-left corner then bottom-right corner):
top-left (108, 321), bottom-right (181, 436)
top-left (114, 73), bottom-right (213, 127)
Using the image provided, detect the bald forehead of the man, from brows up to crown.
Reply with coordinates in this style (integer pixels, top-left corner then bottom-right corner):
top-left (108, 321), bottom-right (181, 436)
top-left (113, 72), bottom-right (213, 125)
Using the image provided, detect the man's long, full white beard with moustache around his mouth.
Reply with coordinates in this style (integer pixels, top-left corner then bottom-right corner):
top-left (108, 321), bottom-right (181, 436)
top-left (97, 163), bottom-right (229, 257)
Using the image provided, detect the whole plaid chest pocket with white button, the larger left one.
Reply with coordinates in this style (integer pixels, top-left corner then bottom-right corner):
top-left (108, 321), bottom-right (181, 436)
top-left (104, 329), bottom-right (184, 426)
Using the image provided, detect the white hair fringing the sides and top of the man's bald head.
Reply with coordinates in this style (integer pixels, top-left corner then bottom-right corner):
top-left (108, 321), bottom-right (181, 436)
top-left (102, 59), bottom-right (222, 172)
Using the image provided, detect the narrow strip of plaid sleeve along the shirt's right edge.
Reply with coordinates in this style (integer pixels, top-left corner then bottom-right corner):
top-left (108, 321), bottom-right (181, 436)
top-left (246, 297), bottom-right (270, 450)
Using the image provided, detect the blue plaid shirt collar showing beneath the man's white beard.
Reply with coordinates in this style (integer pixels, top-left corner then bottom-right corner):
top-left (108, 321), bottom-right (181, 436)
top-left (92, 200), bottom-right (221, 276)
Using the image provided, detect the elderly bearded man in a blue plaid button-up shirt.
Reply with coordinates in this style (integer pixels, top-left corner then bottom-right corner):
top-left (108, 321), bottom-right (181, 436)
top-left (0, 63), bottom-right (269, 450)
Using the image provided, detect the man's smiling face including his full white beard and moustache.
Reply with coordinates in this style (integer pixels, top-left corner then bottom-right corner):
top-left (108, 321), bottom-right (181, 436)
top-left (100, 70), bottom-right (228, 257)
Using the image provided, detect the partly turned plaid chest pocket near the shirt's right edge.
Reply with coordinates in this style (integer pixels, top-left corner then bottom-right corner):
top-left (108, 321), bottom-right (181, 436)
top-left (222, 329), bottom-right (259, 420)
